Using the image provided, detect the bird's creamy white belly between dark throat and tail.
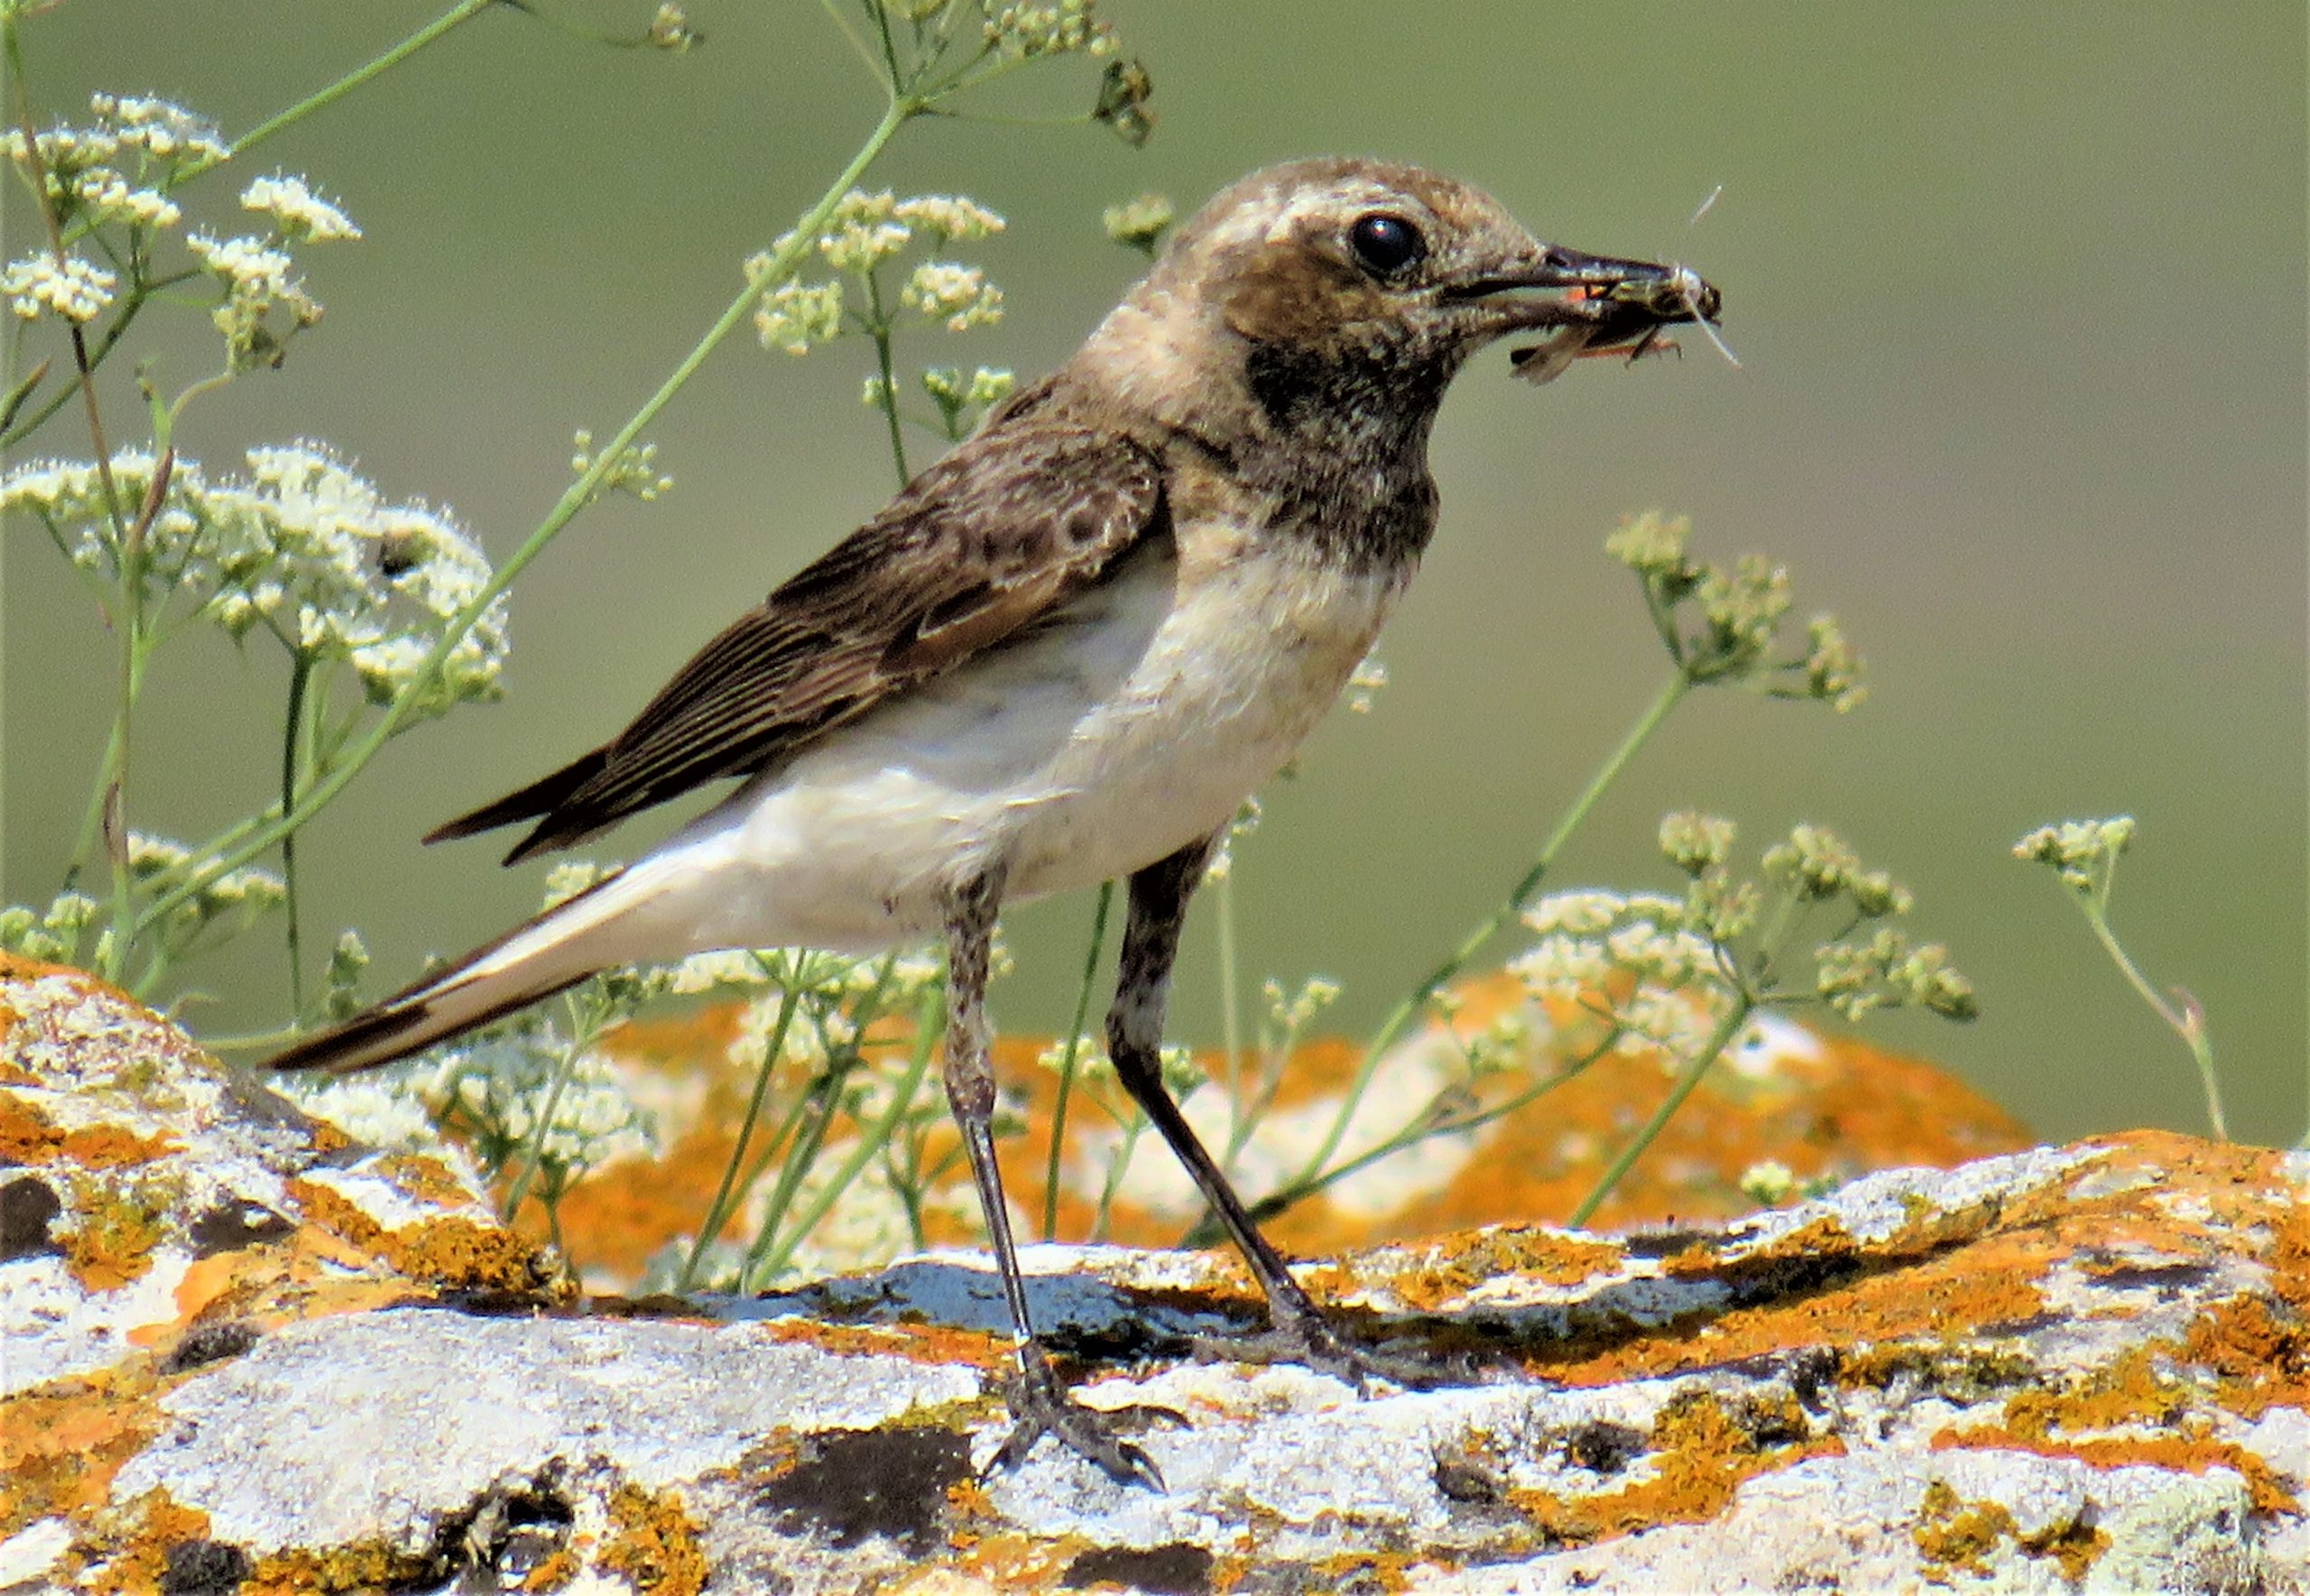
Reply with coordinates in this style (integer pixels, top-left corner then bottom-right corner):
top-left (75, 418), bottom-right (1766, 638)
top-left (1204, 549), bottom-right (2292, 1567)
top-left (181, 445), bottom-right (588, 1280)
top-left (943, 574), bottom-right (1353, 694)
top-left (656, 543), bottom-right (1407, 952)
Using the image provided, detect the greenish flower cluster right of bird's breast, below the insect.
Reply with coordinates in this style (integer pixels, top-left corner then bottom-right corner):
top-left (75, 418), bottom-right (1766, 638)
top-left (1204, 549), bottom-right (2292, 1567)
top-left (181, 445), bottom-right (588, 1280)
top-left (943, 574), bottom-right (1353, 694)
top-left (1603, 511), bottom-right (1866, 711)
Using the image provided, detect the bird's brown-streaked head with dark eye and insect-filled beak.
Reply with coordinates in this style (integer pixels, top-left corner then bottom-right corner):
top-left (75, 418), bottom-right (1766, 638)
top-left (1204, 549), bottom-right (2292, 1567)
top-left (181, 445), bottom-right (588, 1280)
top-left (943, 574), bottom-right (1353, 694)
top-left (1093, 160), bottom-right (1719, 436)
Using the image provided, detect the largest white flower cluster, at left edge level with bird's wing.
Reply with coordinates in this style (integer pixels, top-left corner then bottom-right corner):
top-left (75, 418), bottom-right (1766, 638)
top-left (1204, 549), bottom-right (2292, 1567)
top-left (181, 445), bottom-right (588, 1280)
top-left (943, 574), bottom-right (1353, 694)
top-left (0, 444), bottom-right (508, 716)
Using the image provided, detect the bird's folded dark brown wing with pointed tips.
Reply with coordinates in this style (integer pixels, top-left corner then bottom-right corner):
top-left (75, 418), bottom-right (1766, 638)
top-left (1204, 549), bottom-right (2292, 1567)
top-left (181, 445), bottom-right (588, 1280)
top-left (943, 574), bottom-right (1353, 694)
top-left (425, 420), bottom-right (1167, 863)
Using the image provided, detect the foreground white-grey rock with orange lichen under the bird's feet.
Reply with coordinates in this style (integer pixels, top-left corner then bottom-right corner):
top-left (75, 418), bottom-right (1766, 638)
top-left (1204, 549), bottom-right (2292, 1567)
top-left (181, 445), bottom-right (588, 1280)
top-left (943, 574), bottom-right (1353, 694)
top-left (0, 965), bottom-right (2310, 1596)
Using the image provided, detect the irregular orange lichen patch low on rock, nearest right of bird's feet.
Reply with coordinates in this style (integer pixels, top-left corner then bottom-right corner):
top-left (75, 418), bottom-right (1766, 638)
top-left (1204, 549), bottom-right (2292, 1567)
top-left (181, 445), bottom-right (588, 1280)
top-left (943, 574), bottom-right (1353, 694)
top-left (1506, 1390), bottom-right (1845, 1545)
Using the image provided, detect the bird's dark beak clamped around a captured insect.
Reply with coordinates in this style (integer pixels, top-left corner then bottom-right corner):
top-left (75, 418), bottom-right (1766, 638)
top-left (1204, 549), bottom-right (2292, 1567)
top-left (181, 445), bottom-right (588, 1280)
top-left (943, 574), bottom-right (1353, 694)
top-left (1441, 244), bottom-right (1723, 383)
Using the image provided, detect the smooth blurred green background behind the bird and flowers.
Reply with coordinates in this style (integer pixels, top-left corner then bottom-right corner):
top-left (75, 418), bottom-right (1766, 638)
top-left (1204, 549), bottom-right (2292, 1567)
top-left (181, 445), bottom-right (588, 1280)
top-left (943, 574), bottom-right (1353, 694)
top-left (0, 0), bottom-right (2310, 1141)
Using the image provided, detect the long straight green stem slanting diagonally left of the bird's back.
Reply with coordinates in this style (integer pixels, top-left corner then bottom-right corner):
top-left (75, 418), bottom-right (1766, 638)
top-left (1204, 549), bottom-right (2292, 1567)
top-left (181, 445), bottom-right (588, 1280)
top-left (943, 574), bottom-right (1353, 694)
top-left (139, 99), bottom-right (919, 928)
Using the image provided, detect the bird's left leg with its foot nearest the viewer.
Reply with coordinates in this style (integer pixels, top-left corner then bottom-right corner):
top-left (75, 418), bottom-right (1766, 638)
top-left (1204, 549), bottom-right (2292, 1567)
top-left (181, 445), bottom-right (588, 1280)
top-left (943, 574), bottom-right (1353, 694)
top-left (945, 871), bottom-right (1162, 1490)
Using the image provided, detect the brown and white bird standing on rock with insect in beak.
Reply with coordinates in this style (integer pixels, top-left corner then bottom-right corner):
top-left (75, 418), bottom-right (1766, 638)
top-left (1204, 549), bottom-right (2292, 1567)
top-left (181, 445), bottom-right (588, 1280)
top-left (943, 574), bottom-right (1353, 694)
top-left (268, 157), bottom-right (1721, 1488)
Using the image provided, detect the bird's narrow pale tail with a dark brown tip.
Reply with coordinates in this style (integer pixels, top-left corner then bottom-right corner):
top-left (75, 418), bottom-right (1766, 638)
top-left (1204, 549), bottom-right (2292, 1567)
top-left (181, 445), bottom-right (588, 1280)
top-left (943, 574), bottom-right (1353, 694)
top-left (265, 862), bottom-right (668, 1074)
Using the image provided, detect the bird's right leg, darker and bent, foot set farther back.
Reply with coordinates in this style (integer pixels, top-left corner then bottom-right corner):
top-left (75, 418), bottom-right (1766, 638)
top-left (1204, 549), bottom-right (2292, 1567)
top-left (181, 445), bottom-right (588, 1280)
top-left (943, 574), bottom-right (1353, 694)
top-left (1106, 836), bottom-right (1441, 1388)
